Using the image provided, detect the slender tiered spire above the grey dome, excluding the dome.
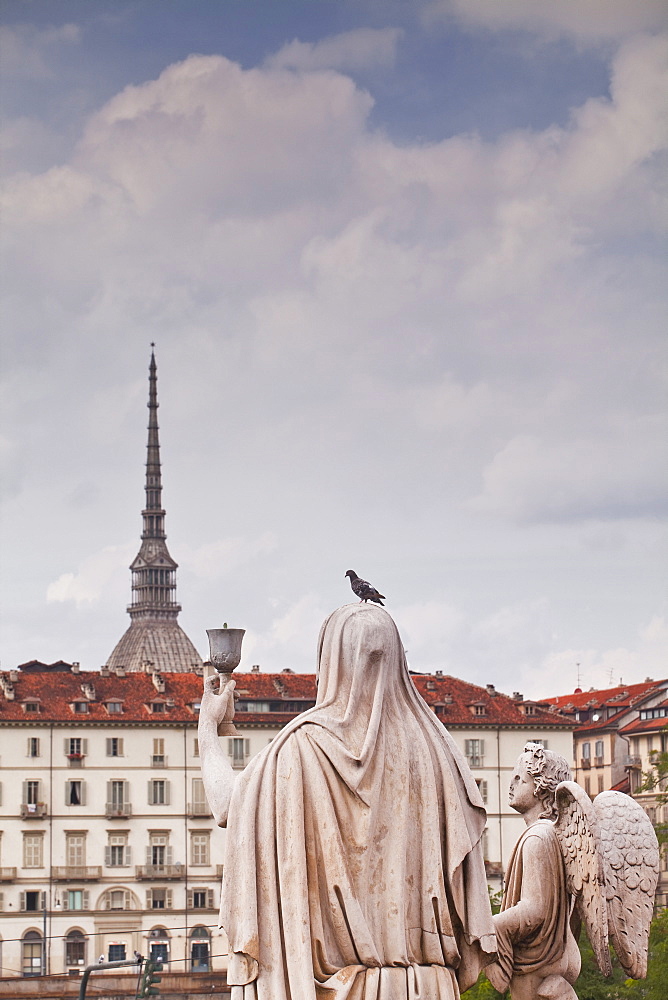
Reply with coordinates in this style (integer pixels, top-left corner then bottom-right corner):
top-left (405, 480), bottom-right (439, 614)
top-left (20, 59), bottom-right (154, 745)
top-left (128, 344), bottom-right (181, 620)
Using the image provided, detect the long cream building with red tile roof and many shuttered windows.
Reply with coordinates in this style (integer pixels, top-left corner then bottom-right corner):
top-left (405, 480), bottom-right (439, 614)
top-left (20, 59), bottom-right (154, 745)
top-left (0, 662), bottom-right (572, 976)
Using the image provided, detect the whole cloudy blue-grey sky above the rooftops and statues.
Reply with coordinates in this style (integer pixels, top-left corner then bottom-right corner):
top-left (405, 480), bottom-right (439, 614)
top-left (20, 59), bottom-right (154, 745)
top-left (0, 0), bottom-right (668, 696)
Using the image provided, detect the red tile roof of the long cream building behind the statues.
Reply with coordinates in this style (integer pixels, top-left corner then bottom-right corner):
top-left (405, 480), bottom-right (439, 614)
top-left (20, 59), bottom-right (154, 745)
top-left (0, 661), bottom-right (573, 729)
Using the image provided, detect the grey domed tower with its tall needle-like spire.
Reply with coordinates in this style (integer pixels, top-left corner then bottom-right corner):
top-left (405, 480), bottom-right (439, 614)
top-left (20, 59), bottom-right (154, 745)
top-left (107, 344), bottom-right (202, 671)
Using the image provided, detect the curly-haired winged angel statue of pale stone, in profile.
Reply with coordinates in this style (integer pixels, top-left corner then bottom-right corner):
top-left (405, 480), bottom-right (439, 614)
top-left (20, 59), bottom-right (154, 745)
top-left (485, 743), bottom-right (659, 1000)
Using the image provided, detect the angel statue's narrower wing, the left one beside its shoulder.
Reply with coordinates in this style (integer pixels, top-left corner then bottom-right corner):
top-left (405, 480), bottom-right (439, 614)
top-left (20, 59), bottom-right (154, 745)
top-left (554, 781), bottom-right (612, 976)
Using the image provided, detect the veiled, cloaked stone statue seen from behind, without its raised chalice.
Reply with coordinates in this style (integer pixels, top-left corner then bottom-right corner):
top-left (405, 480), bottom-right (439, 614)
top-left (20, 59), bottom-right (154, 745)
top-left (199, 604), bottom-right (495, 1000)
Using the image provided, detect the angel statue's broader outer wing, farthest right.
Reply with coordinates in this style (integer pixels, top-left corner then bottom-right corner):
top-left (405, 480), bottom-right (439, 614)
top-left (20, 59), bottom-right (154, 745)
top-left (594, 792), bottom-right (659, 979)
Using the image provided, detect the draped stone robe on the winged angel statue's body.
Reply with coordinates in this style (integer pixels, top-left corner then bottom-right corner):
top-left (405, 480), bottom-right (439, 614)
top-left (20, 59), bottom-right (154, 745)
top-left (487, 820), bottom-right (570, 993)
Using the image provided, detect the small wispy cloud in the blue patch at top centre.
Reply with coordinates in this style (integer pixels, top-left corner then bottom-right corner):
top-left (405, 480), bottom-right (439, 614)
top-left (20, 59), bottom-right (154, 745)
top-left (265, 28), bottom-right (403, 72)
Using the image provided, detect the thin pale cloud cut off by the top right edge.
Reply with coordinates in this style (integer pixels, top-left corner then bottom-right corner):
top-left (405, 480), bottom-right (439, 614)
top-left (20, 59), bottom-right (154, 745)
top-left (425, 0), bottom-right (668, 42)
